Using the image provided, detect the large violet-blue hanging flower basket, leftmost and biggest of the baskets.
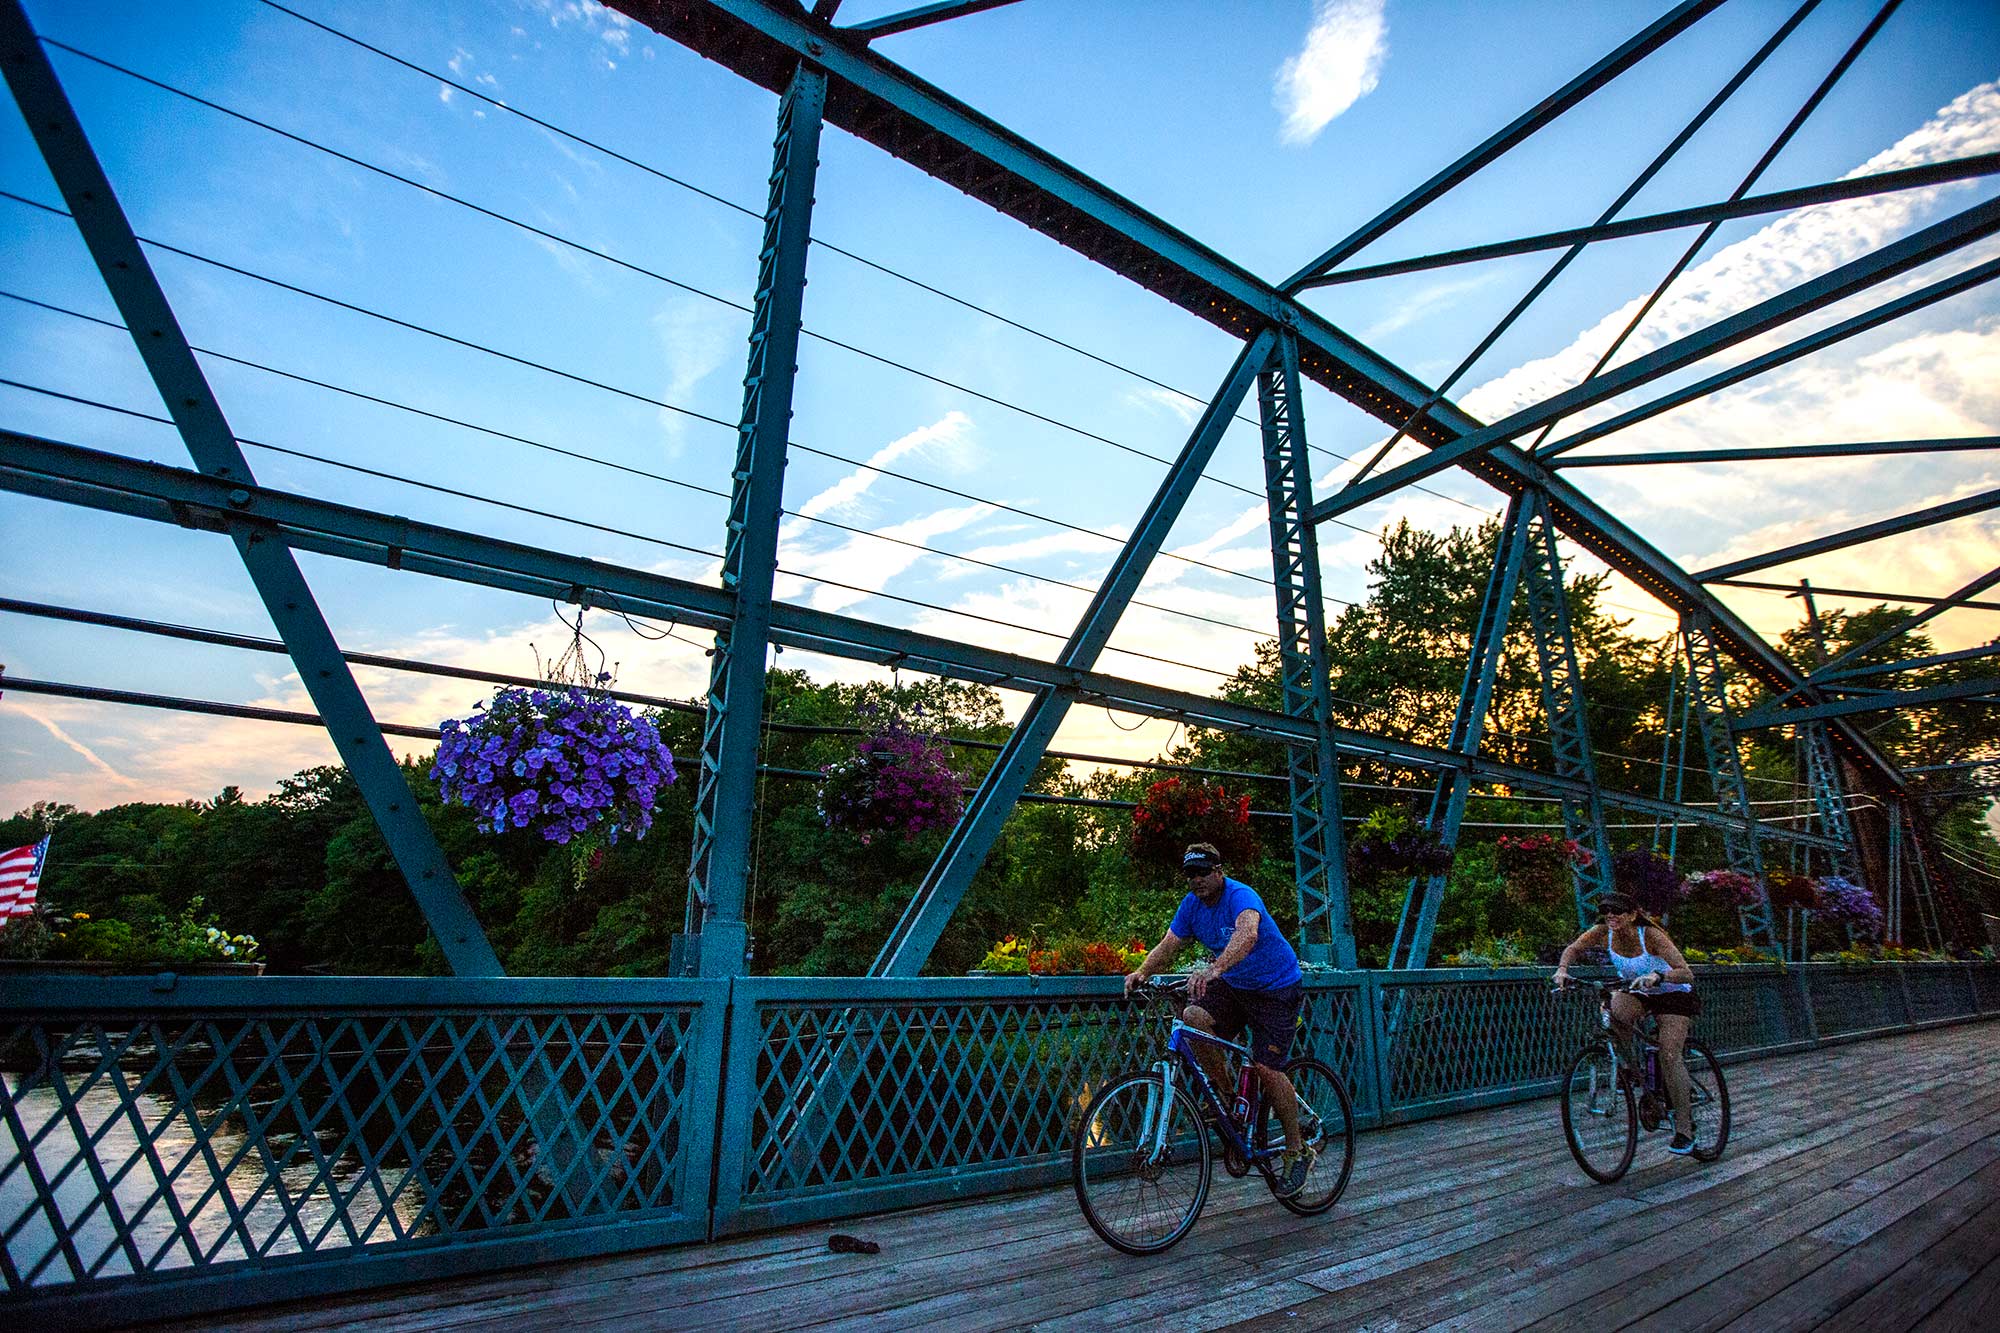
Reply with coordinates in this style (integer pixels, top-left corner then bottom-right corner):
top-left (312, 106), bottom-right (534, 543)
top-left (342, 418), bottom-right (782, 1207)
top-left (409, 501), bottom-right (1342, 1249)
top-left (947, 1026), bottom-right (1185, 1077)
top-left (430, 685), bottom-right (674, 845)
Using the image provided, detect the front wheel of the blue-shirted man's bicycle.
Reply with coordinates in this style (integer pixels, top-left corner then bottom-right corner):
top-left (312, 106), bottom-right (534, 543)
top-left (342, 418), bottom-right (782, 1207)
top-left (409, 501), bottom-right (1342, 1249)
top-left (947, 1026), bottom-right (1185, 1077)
top-left (1070, 1071), bottom-right (1214, 1255)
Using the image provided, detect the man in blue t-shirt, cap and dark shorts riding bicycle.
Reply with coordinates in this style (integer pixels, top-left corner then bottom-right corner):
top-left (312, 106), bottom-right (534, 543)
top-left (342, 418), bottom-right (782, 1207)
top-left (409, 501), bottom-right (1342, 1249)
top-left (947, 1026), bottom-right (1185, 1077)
top-left (1126, 843), bottom-right (1312, 1199)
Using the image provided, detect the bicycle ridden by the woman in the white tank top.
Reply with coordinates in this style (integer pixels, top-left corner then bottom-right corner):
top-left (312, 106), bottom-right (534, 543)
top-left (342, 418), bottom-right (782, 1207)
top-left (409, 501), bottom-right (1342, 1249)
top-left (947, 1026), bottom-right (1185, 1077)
top-left (1562, 983), bottom-right (1730, 1185)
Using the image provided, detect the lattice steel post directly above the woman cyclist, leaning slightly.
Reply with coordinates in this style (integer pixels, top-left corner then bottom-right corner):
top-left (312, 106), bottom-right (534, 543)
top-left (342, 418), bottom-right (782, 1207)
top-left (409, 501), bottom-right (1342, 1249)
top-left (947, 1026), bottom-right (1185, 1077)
top-left (1522, 490), bottom-right (1612, 923)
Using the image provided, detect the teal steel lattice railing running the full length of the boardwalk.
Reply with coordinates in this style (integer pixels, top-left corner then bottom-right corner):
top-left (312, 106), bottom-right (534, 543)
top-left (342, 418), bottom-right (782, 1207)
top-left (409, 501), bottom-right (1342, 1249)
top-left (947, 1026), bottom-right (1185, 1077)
top-left (0, 963), bottom-right (2000, 1325)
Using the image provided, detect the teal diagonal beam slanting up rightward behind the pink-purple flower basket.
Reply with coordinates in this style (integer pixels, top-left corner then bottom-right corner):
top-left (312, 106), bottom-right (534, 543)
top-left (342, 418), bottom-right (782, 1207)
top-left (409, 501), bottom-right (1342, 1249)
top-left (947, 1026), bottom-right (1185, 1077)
top-left (868, 328), bottom-right (1272, 977)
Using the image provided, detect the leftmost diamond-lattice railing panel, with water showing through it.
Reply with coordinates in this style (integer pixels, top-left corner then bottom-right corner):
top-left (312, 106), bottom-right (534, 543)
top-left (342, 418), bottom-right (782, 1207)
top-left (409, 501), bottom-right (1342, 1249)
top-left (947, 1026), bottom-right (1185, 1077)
top-left (0, 1007), bottom-right (706, 1291)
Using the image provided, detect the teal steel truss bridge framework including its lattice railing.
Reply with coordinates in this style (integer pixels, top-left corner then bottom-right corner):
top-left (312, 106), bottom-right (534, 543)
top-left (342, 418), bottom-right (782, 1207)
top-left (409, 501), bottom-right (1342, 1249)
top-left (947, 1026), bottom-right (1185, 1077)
top-left (0, 0), bottom-right (2000, 1319)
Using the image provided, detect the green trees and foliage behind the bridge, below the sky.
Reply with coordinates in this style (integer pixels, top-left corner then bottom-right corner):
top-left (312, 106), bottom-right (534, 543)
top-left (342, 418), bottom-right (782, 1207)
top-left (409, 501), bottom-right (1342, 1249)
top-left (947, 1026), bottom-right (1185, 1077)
top-left (19, 524), bottom-right (2000, 975)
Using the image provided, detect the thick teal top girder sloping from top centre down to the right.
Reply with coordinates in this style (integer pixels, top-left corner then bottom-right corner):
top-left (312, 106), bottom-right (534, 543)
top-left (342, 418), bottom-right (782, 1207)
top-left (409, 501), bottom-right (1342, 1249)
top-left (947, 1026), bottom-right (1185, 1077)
top-left (612, 0), bottom-right (1902, 791)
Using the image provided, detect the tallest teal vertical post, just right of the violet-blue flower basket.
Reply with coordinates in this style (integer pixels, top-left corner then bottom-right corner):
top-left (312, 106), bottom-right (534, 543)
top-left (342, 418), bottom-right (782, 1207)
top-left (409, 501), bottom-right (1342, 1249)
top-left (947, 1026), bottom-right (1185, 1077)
top-left (670, 64), bottom-right (826, 977)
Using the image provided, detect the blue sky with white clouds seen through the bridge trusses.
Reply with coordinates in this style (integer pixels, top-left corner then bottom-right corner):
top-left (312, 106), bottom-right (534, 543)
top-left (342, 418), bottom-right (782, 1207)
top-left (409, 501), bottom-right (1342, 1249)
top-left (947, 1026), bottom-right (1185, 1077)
top-left (0, 0), bottom-right (2000, 811)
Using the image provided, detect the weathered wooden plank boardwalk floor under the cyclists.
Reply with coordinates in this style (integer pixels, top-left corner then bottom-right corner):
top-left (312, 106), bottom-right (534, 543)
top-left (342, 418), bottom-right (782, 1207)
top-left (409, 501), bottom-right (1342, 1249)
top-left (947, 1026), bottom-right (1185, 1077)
top-left (152, 1023), bottom-right (2000, 1333)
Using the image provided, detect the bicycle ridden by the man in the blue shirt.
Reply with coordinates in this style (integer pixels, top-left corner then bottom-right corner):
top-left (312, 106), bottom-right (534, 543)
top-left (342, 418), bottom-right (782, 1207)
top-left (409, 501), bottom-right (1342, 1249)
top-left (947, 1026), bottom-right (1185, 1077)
top-left (1070, 981), bottom-right (1354, 1255)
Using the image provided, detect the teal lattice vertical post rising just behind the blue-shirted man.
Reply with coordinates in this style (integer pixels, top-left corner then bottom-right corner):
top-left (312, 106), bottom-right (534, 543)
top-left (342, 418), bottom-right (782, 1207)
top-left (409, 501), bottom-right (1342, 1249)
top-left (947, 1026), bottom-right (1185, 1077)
top-left (1256, 332), bottom-right (1356, 967)
